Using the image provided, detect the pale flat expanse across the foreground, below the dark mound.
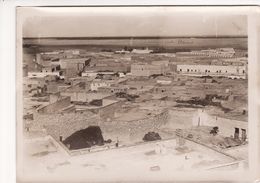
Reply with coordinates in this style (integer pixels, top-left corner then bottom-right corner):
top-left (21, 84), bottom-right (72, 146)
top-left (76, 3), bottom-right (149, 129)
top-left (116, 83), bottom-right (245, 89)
top-left (19, 135), bottom-right (242, 181)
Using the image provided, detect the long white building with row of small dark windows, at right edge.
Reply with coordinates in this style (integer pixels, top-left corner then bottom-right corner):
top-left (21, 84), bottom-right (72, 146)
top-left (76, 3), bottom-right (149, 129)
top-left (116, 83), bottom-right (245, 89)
top-left (177, 65), bottom-right (246, 79)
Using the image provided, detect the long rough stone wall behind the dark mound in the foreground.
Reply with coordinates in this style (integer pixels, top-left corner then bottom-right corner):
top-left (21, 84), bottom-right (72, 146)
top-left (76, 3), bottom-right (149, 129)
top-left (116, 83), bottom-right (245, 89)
top-left (30, 110), bottom-right (169, 144)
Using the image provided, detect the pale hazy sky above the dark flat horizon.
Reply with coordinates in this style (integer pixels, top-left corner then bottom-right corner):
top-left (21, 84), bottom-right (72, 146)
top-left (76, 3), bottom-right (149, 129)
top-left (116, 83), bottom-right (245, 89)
top-left (20, 7), bottom-right (247, 37)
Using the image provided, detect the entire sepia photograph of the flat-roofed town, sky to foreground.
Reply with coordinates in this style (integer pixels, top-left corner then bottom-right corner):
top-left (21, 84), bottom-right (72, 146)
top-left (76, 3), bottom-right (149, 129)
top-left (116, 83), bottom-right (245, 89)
top-left (16, 7), bottom-right (252, 182)
